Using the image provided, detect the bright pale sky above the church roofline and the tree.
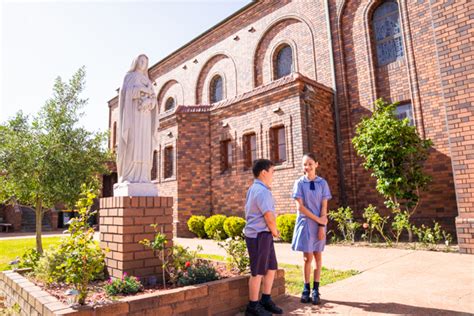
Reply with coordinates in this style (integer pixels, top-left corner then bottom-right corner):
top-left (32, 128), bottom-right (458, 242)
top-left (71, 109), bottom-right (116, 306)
top-left (0, 0), bottom-right (250, 131)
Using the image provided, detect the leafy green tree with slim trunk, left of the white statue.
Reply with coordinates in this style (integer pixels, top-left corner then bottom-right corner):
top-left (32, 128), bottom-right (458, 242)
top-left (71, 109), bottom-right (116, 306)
top-left (0, 67), bottom-right (109, 253)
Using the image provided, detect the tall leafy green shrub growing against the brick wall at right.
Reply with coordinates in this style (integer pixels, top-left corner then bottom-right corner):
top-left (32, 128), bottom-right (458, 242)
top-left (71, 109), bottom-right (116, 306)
top-left (352, 99), bottom-right (432, 240)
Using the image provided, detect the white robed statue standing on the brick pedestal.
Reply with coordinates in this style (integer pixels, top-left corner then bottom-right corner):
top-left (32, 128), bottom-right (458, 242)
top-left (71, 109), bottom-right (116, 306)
top-left (114, 55), bottom-right (157, 196)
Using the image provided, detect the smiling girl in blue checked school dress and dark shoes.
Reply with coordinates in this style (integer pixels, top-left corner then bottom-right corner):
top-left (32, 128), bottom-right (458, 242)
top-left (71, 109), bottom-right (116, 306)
top-left (291, 153), bottom-right (331, 304)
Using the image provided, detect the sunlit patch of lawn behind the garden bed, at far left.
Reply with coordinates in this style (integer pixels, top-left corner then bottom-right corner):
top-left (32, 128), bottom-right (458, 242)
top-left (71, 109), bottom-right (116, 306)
top-left (0, 237), bottom-right (61, 271)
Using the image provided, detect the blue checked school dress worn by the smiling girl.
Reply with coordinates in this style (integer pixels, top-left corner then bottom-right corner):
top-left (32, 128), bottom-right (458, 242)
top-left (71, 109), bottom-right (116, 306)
top-left (291, 176), bottom-right (332, 252)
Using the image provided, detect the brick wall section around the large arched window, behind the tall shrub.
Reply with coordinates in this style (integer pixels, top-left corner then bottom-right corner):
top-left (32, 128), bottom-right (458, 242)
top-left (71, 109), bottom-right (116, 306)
top-left (330, 0), bottom-right (457, 229)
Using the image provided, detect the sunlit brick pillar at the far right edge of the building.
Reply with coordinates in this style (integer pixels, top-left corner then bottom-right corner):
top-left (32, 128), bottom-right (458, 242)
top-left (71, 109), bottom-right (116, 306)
top-left (431, 0), bottom-right (474, 254)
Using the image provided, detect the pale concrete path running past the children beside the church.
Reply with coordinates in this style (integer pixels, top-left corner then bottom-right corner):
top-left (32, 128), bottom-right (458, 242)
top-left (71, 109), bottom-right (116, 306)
top-left (175, 238), bottom-right (474, 315)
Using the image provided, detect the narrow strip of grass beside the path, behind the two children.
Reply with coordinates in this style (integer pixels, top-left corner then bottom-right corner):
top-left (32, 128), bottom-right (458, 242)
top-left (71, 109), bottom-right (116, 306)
top-left (198, 254), bottom-right (359, 295)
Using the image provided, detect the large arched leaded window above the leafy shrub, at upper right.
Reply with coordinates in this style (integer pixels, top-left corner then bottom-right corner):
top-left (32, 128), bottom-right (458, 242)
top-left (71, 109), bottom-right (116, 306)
top-left (372, 0), bottom-right (403, 66)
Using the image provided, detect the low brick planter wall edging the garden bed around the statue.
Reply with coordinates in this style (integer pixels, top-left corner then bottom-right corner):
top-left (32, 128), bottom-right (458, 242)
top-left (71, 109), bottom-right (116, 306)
top-left (0, 270), bottom-right (285, 316)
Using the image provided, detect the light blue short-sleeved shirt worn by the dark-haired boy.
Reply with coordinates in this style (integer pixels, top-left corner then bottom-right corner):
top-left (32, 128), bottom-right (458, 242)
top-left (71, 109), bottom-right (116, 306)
top-left (244, 179), bottom-right (275, 238)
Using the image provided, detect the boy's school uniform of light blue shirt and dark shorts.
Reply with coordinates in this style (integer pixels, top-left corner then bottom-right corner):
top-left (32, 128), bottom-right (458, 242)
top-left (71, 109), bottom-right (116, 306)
top-left (244, 179), bottom-right (278, 276)
